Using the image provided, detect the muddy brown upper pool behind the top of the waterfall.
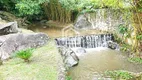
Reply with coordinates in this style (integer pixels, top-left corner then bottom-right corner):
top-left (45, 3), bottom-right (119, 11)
top-left (29, 23), bottom-right (107, 38)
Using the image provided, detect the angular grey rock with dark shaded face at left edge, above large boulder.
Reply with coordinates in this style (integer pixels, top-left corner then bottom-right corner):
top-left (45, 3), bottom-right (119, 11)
top-left (0, 22), bottom-right (18, 35)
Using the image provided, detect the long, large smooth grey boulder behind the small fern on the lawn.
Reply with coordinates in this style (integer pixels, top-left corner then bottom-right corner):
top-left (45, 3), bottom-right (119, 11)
top-left (0, 33), bottom-right (49, 60)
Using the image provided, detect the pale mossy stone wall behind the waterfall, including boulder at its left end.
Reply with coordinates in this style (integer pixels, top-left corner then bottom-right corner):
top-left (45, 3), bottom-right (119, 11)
top-left (74, 9), bottom-right (131, 31)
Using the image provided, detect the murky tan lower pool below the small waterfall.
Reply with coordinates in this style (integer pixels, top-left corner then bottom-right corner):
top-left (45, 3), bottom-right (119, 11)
top-left (68, 48), bottom-right (142, 80)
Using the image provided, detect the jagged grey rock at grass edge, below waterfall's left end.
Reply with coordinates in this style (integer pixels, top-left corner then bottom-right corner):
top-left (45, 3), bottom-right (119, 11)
top-left (59, 47), bottom-right (79, 68)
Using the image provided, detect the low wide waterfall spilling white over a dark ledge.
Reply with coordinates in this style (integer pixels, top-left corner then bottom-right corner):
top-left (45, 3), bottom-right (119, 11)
top-left (55, 34), bottom-right (114, 48)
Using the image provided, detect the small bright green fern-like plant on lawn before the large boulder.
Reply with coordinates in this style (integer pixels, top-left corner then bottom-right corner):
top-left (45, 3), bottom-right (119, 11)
top-left (15, 49), bottom-right (33, 62)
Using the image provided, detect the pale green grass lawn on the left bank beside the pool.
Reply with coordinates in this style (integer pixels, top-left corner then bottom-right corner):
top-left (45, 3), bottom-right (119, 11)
top-left (0, 41), bottom-right (60, 80)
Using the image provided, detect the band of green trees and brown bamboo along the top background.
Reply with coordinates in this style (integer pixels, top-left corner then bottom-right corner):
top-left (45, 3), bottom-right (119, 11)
top-left (0, 0), bottom-right (133, 22)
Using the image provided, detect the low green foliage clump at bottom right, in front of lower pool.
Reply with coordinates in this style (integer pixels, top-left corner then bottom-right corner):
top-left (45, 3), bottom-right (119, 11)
top-left (105, 70), bottom-right (133, 80)
